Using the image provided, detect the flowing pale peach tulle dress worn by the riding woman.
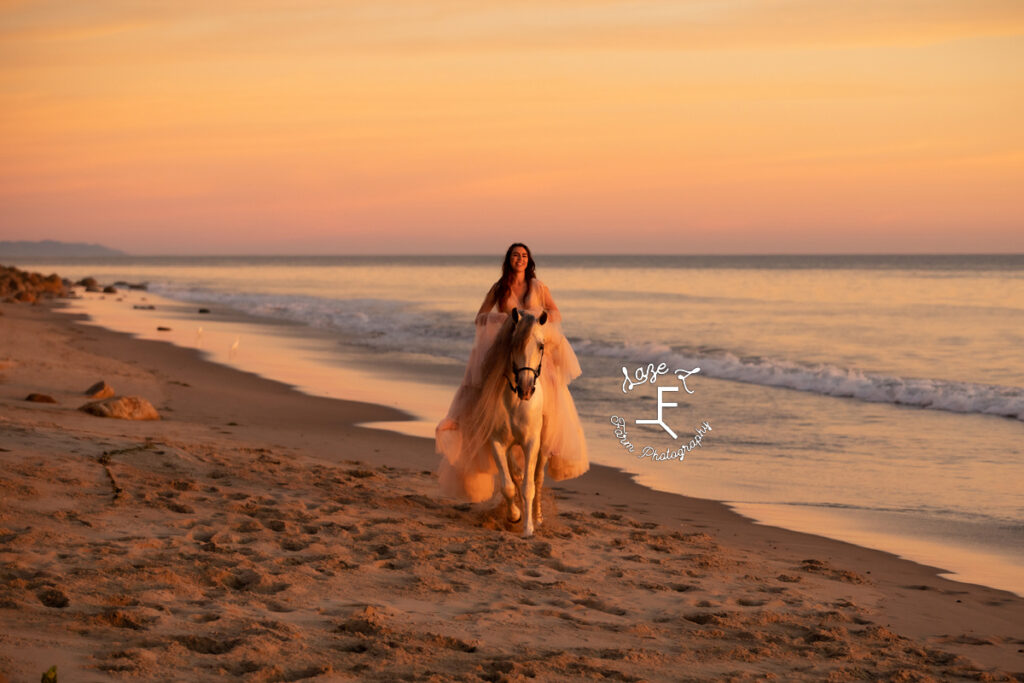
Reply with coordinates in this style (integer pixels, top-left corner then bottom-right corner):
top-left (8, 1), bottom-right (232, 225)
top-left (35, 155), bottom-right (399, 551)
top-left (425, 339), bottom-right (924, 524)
top-left (434, 279), bottom-right (590, 503)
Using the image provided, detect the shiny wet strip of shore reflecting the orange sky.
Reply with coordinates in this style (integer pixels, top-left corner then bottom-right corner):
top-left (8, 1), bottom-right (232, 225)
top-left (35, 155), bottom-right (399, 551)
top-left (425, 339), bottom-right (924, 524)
top-left (58, 291), bottom-right (1024, 597)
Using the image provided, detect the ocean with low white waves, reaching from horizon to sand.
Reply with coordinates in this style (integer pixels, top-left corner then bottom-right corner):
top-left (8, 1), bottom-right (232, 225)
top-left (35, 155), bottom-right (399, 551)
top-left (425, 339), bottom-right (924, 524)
top-left (16, 254), bottom-right (1024, 595)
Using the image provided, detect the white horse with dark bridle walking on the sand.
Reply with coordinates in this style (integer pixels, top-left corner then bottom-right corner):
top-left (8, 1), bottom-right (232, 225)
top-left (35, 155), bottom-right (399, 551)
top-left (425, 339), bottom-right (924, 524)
top-left (490, 308), bottom-right (548, 538)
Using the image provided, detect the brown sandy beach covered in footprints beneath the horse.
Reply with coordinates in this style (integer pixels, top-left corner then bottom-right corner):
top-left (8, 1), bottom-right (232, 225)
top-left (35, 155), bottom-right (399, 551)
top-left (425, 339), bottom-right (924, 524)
top-left (0, 304), bottom-right (1024, 682)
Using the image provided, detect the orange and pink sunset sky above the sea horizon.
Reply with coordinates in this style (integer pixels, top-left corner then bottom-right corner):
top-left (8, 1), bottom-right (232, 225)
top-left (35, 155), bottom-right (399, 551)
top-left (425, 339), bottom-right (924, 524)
top-left (0, 0), bottom-right (1024, 254)
